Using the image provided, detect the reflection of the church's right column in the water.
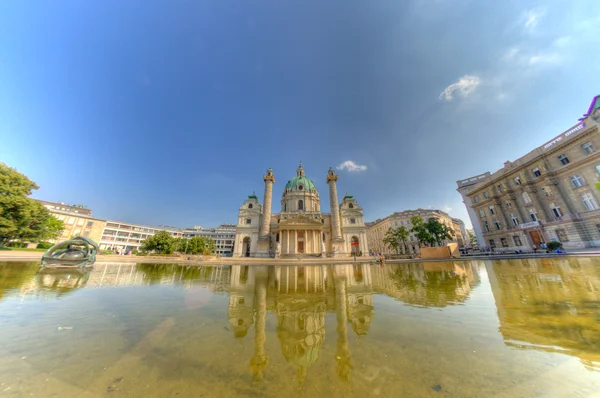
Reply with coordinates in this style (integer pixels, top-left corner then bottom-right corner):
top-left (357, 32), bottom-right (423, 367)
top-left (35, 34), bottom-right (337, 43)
top-left (334, 269), bottom-right (352, 381)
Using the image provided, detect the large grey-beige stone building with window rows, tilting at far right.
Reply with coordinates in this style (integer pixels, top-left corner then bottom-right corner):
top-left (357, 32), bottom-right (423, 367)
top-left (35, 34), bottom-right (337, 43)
top-left (457, 96), bottom-right (600, 250)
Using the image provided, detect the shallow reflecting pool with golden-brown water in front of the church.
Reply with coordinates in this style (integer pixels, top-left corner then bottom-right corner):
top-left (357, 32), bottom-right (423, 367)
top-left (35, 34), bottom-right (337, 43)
top-left (0, 257), bottom-right (600, 397)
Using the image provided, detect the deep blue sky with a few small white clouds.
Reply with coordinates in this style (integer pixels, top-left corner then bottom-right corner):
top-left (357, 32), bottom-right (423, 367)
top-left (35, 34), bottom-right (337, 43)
top-left (0, 0), bottom-right (600, 227)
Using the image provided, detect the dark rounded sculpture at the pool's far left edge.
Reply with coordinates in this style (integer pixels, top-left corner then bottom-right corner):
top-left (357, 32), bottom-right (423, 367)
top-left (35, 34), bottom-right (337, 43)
top-left (42, 236), bottom-right (98, 267)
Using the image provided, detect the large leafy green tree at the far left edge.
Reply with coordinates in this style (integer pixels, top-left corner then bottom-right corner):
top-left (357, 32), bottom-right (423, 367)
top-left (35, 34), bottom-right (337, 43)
top-left (0, 163), bottom-right (64, 243)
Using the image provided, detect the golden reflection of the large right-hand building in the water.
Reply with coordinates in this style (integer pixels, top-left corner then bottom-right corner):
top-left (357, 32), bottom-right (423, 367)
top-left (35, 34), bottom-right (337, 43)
top-left (486, 257), bottom-right (600, 370)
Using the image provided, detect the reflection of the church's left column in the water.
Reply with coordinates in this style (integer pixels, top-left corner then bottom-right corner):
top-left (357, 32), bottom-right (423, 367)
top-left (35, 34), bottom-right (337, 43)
top-left (250, 266), bottom-right (269, 380)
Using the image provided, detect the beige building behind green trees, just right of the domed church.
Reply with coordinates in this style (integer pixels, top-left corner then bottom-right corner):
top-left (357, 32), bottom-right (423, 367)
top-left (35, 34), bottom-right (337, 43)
top-left (367, 209), bottom-right (464, 254)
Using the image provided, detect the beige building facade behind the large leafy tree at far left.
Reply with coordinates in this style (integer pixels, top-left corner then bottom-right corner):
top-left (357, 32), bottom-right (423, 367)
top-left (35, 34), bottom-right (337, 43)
top-left (39, 200), bottom-right (106, 242)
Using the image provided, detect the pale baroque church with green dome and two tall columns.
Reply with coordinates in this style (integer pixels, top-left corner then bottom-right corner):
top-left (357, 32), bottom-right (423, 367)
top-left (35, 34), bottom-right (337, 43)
top-left (233, 162), bottom-right (369, 258)
